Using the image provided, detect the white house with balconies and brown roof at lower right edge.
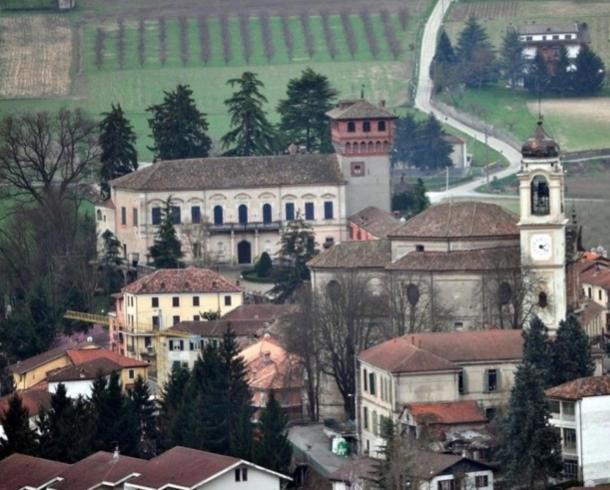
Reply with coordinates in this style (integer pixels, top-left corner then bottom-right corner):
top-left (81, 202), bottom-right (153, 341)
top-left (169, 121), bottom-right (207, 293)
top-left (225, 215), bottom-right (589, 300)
top-left (546, 376), bottom-right (610, 486)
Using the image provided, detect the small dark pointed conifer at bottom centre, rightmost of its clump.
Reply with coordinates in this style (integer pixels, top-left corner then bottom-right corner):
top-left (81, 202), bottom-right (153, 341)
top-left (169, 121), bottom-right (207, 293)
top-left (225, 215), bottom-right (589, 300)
top-left (254, 391), bottom-right (292, 475)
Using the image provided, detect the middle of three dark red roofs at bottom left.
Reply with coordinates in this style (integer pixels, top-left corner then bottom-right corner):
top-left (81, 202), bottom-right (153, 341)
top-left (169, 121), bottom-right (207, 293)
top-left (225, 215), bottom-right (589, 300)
top-left (53, 451), bottom-right (148, 490)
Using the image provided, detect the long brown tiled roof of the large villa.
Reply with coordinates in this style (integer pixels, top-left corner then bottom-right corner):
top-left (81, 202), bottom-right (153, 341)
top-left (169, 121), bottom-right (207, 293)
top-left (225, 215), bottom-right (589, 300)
top-left (110, 154), bottom-right (344, 191)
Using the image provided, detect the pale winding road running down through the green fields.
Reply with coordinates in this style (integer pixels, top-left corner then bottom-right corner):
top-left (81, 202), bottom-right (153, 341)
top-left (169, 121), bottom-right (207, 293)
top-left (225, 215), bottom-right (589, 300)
top-left (415, 0), bottom-right (521, 202)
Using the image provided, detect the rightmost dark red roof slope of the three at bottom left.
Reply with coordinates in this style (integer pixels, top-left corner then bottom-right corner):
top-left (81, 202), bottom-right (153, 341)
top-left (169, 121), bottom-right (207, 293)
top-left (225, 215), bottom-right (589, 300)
top-left (130, 446), bottom-right (241, 488)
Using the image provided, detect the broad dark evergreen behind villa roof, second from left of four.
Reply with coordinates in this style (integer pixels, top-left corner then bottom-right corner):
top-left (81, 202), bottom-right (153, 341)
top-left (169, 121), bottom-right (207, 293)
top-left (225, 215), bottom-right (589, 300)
top-left (146, 85), bottom-right (212, 160)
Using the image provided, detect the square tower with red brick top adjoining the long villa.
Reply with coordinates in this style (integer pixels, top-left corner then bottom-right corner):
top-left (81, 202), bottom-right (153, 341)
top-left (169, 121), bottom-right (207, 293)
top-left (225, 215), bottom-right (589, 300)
top-left (326, 99), bottom-right (396, 216)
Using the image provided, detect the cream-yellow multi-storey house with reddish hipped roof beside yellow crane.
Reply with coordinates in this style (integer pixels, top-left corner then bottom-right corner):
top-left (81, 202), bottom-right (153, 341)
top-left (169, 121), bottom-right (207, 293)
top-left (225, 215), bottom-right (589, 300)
top-left (111, 267), bottom-right (243, 375)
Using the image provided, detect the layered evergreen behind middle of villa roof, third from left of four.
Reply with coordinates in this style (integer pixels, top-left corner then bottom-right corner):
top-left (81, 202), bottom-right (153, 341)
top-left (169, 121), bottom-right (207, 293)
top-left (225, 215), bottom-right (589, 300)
top-left (221, 71), bottom-right (275, 156)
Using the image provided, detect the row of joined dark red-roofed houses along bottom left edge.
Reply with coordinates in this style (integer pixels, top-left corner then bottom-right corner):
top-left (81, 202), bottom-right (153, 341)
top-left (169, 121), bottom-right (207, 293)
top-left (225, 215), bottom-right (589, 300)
top-left (0, 446), bottom-right (290, 490)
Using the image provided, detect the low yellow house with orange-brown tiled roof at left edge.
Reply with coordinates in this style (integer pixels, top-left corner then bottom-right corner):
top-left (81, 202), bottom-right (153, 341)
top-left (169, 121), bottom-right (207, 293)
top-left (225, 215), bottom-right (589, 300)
top-left (10, 343), bottom-right (148, 391)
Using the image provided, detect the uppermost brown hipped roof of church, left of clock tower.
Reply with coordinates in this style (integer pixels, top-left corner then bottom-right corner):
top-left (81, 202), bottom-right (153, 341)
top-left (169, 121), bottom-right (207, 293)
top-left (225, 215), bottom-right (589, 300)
top-left (390, 201), bottom-right (519, 238)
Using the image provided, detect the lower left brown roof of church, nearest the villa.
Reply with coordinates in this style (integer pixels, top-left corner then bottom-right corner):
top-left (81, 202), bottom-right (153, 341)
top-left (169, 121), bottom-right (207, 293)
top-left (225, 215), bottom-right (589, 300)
top-left (307, 239), bottom-right (392, 269)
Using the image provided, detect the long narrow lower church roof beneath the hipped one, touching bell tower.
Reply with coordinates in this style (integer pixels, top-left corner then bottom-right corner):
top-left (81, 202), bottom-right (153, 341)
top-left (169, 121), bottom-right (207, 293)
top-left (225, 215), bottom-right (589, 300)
top-left (387, 247), bottom-right (521, 272)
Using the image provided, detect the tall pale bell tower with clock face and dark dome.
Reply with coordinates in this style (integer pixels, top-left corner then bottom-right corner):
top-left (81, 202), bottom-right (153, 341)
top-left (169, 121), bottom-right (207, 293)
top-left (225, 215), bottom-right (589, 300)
top-left (517, 120), bottom-right (568, 333)
